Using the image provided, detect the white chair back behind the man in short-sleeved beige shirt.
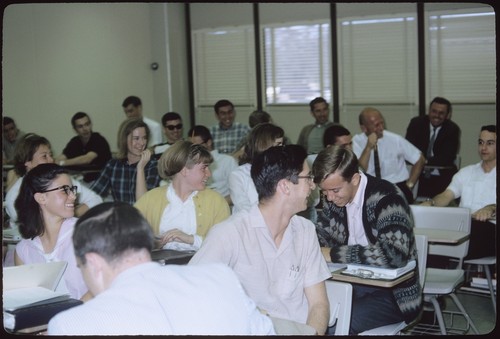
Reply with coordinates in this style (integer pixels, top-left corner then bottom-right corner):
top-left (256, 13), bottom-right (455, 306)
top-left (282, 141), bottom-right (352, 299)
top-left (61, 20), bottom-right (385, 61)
top-left (325, 280), bottom-right (352, 335)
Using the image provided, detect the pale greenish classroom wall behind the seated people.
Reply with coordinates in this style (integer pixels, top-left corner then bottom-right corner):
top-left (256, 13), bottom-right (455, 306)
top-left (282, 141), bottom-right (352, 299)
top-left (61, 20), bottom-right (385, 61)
top-left (2, 3), bottom-right (496, 166)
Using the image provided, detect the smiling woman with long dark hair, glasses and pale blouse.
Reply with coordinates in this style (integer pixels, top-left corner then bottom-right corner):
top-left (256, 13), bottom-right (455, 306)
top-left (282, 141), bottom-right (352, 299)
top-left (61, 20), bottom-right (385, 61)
top-left (14, 164), bottom-right (90, 300)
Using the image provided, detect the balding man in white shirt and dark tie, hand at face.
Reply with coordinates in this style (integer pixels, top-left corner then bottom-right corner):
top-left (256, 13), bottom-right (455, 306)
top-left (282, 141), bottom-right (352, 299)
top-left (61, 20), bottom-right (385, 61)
top-left (352, 107), bottom-right (425, 204)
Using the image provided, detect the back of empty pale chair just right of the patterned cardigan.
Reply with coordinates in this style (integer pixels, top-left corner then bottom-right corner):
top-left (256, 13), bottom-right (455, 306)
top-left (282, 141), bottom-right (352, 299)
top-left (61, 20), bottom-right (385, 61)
top-left (410, 205), bottom-right (471, 267)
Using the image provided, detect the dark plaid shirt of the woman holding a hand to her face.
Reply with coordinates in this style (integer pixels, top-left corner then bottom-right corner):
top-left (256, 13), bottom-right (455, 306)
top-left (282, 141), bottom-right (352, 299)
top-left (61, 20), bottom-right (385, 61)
top-left (90, 158), bottom-right (161, 205)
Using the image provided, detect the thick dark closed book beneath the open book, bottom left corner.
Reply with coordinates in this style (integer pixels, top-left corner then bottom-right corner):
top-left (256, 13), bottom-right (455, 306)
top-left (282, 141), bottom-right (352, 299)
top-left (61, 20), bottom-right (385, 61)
top-left (3, 298), bottom-right (83, 332)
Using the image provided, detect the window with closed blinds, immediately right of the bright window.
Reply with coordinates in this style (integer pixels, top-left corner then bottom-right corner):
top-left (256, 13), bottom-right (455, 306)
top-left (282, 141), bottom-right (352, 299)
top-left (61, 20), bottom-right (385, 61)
top-left (338, 13), bottom-right (418, 105)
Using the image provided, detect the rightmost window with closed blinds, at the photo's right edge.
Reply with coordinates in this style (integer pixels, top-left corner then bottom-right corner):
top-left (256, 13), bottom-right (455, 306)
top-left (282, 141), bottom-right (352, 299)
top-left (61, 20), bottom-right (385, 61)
top-left (427, 9), bottom-right (496, 104)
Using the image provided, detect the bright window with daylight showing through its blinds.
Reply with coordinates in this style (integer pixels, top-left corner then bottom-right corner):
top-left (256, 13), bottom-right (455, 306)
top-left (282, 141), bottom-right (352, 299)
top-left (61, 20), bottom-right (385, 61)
top-left (263, 22), bottom-right (331, 105)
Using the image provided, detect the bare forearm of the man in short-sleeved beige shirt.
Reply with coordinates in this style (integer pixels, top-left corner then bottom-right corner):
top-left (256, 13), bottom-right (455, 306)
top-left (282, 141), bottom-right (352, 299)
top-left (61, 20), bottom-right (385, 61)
top-left (304, 281), bottom-right (330, 335)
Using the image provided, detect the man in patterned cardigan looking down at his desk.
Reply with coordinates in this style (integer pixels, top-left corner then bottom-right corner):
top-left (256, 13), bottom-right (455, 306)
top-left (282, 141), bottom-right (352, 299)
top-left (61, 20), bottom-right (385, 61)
top-left (313, 146), bottom-right (422, 334)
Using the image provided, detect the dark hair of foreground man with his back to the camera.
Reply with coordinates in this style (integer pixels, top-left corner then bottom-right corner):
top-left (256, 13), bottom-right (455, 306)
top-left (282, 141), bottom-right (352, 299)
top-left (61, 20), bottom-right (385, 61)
top-left (73, 201), bottom-right (154, 265)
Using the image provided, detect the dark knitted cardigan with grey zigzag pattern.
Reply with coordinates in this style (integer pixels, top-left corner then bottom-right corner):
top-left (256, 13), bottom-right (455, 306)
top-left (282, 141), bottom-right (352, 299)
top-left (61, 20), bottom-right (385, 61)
top-left (316, 175), bottom-right (422, 323)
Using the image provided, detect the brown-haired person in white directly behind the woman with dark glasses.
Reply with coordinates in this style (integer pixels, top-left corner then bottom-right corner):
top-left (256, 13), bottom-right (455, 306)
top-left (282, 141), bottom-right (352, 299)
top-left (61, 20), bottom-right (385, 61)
top-left (5, 133), bottom-right (102, 227)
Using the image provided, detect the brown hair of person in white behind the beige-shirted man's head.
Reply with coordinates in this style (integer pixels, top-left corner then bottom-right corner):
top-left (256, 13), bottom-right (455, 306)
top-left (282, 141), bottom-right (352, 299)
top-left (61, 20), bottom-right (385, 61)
top-left (239, 122), bottom-right (285, 165)
